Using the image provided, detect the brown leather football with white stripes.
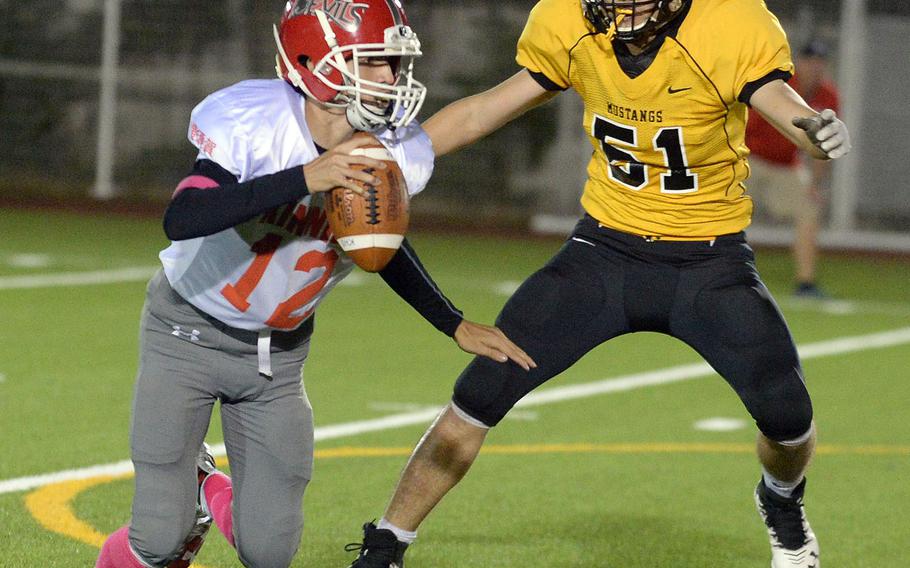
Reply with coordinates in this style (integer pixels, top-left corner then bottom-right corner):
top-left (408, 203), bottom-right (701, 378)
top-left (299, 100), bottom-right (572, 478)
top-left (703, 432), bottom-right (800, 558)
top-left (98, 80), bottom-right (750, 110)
top-left (325, 132), bottom-right (410, 272)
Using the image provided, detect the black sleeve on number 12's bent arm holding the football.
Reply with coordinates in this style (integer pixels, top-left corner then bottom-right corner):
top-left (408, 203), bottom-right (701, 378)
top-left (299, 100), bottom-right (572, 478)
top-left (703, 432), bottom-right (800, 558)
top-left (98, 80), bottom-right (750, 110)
top-left (164, 160), bottom-right (309, 241)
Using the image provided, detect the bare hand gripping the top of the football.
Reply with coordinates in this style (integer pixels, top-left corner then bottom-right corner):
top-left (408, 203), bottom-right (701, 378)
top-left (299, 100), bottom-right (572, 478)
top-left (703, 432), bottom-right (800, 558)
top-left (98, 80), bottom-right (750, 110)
top-left (303, 136), bottom-right (386, 195)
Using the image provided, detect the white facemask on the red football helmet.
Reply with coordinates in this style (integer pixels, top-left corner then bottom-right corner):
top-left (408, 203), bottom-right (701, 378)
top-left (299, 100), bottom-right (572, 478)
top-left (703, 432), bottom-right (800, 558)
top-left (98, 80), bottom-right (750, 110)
top-left (275, 10), bottom-right (426, 131)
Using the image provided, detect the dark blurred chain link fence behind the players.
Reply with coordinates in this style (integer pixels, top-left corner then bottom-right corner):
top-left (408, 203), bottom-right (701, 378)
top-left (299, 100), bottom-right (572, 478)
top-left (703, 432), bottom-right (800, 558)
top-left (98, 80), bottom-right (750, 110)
top-left (0, 0), bottom-right (910, 245)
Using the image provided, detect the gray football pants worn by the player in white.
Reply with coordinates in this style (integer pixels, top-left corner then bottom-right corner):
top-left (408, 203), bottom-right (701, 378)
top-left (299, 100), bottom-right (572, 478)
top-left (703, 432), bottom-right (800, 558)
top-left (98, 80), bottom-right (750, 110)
top-left (129, 273), bottom-right (313, 568)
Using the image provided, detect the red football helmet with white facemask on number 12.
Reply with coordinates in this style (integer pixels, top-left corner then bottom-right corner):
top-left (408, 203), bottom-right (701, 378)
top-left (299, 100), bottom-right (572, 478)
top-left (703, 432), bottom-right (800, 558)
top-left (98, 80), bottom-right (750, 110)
top-left (275, 0), bottom-right (426, 130)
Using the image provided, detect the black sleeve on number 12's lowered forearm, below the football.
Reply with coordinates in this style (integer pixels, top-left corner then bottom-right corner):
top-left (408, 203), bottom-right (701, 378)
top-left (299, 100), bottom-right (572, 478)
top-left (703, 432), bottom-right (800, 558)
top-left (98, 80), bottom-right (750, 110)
top-left (379, 239), bottom-right (464, 337)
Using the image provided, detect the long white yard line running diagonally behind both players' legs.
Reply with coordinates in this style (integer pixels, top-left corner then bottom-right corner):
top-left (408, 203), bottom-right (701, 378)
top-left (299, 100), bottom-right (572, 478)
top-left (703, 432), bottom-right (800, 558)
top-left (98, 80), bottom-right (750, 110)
top-left (0, 327), bottom-right (910, 495)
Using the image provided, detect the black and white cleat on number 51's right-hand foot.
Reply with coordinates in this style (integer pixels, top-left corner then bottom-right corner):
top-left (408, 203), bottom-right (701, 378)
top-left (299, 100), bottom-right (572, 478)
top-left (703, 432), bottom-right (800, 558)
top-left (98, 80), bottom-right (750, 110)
top-left (755, 479), bottom-right (821, 568)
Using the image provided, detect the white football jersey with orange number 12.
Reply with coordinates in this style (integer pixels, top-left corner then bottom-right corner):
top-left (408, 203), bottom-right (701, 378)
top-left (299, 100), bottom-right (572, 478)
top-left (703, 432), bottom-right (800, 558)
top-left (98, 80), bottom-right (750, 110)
top-left (159, 79), bottom-right (434, 331)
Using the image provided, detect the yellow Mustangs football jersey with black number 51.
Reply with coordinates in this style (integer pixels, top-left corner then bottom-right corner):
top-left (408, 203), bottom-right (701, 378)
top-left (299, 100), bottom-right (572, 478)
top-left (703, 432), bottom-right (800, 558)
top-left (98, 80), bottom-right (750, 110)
top-left (516, 0), bottom-right (793, 240)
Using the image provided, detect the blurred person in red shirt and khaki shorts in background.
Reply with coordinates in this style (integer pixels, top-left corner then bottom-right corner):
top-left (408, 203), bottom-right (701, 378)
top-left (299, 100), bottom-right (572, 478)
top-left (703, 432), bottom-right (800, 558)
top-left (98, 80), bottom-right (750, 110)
top-left (746, 39), bottom-right (840, 299)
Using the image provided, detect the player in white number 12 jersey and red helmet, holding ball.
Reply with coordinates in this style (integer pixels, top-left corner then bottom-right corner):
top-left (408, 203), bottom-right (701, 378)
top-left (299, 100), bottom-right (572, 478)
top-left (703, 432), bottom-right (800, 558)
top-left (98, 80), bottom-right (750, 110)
top-left (96, 0), bottom-right (534, 568)
